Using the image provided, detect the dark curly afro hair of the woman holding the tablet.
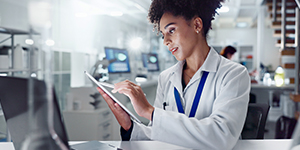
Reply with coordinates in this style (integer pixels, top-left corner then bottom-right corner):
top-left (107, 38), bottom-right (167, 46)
top-left (148, 0), bottom-right (224, 37)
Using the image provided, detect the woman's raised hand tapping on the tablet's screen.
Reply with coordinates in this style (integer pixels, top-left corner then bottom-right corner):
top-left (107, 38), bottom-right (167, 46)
top-left (112, 80), bottom-right (154, 121)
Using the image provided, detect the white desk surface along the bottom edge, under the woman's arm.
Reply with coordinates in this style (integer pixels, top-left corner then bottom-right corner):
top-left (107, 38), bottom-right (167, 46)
top-left (0, 139), bottom-right (292, 150)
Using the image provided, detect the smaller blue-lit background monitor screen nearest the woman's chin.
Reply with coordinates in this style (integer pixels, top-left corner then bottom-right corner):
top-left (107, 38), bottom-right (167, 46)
top-left (142, 53), bottom-right (159, 71)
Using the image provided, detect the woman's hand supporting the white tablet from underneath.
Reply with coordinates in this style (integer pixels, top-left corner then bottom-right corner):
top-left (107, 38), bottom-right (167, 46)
top-left (97, 87), bottom-right (132, 131)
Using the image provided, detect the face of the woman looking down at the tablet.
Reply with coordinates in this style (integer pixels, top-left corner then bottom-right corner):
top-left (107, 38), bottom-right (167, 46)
top-left (159, 13), bottom-right (201, 61)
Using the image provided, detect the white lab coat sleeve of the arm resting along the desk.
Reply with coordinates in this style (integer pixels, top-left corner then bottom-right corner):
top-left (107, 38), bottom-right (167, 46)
top-left (151, 67), bottom-right (250, 150)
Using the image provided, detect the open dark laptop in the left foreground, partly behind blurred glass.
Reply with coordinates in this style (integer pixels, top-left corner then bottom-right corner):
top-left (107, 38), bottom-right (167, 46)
top-left (0, 76), bottom-right (119, 150)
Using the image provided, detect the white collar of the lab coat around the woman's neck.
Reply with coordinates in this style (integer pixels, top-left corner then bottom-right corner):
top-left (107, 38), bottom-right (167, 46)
top-left (170, 47), bottom-right (220, 91)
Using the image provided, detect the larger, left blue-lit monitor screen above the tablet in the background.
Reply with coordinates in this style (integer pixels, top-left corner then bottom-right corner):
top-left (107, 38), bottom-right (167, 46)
top-left (104, 47), bottom-right (130, 73)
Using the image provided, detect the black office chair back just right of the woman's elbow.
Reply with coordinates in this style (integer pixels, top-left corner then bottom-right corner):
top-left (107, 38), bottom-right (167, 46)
top-left (242, 103), bottom-right (270, 139)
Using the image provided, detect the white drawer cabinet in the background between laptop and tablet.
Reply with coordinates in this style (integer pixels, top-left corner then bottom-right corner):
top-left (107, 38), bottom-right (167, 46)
top-left (63, 108), bottom-right (112, 141)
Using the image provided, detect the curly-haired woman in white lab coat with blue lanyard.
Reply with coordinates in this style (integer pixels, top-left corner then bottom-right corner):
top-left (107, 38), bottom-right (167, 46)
top-left (98, 0), bottom-right (250, 150)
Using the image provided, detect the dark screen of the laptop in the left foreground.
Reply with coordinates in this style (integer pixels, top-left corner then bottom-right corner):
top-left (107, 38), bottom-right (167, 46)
top-left (0, 77), bottom-right (69, 149)
